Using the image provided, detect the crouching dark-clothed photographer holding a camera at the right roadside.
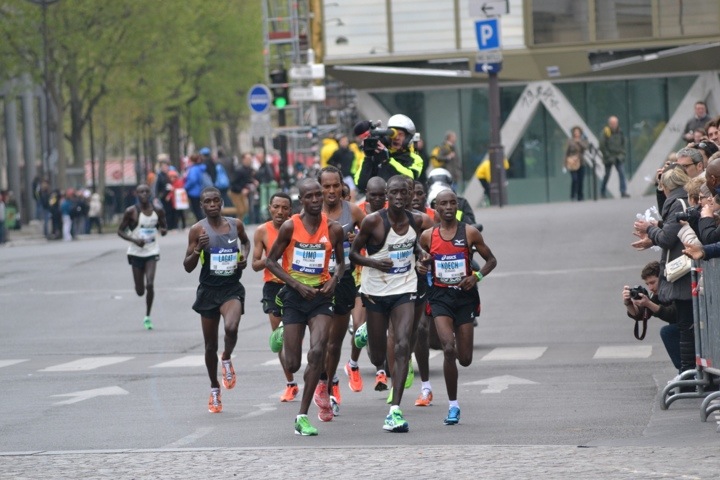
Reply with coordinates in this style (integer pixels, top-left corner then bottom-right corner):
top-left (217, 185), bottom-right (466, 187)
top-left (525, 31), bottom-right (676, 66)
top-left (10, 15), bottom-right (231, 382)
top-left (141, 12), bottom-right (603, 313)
top-left (622, 261), bottom-right (680, 371)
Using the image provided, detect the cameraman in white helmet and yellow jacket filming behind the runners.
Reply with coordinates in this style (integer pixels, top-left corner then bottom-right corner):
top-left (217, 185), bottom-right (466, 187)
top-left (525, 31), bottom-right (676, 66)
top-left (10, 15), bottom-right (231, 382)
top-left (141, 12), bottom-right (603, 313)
top-left (355, 115), bottom-right (423, 191)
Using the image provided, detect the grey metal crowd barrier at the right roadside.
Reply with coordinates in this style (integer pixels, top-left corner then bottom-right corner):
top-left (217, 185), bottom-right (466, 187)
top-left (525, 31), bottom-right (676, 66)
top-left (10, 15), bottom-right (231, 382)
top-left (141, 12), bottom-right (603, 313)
top-left (660, 259), bottom-right (720, 416)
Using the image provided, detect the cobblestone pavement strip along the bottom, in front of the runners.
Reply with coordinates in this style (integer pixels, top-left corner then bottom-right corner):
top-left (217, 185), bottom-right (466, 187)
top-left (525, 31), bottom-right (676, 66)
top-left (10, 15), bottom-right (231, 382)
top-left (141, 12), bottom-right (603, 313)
top-left (0, 446), bottom-right (720, 480)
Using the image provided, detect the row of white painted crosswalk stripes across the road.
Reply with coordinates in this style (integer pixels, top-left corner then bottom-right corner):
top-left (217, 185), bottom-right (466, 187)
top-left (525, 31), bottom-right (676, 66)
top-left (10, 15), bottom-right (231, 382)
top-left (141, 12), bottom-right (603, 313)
top-left (0, 345), bottom-right (666, 373)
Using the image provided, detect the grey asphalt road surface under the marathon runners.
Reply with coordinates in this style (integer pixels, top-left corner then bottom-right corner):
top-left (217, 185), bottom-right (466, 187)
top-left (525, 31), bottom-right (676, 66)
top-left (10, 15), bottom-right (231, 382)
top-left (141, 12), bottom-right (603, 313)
top-left (0, 197), bottom-right (719, 478)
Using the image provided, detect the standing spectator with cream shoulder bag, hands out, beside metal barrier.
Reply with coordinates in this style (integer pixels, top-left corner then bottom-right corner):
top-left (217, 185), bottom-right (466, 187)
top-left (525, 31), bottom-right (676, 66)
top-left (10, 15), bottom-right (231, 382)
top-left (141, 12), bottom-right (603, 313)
top-left (633, 164), bottom-right (695, 371)
